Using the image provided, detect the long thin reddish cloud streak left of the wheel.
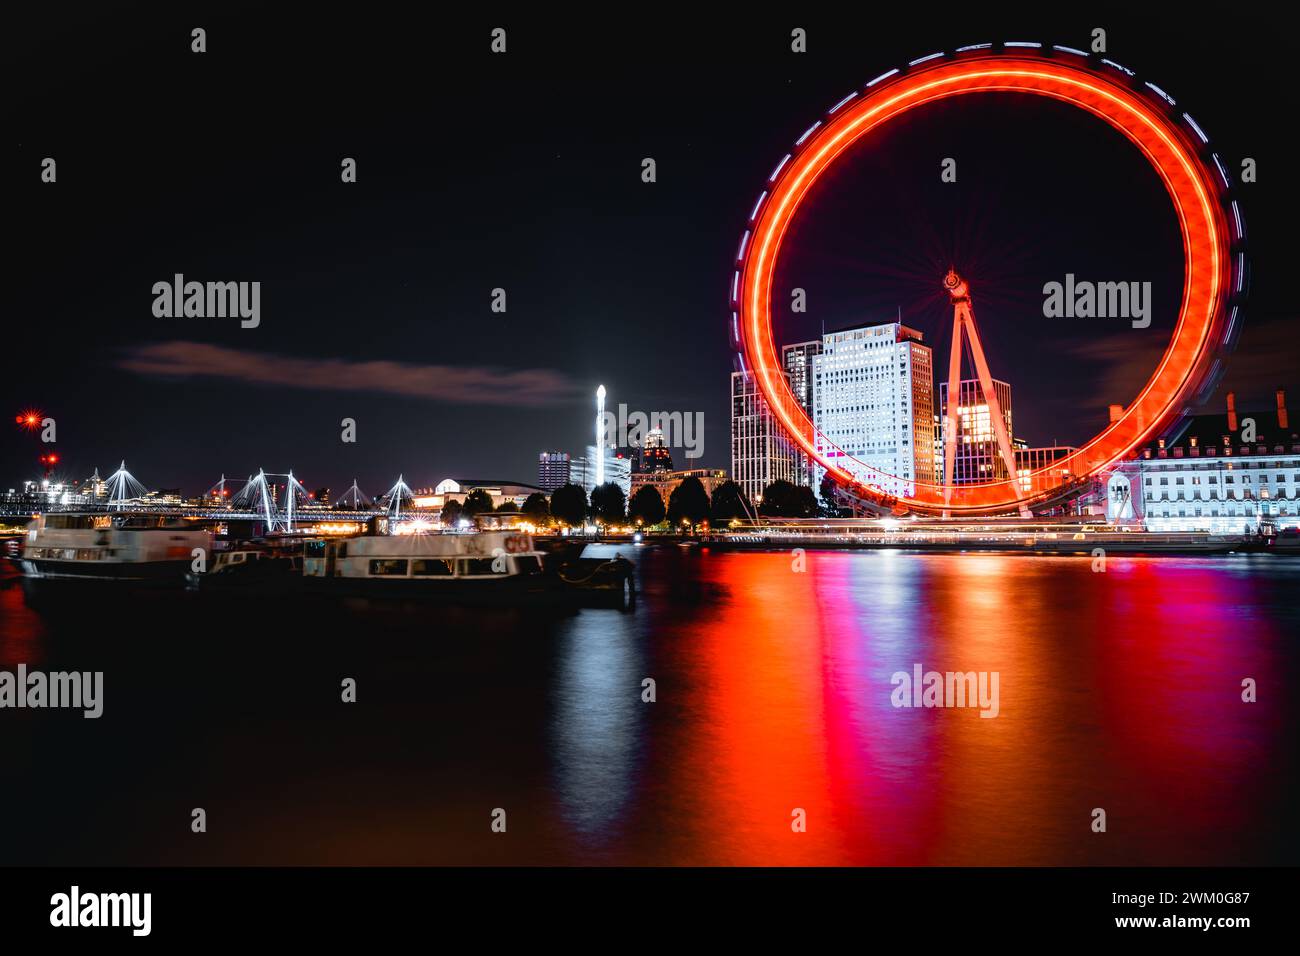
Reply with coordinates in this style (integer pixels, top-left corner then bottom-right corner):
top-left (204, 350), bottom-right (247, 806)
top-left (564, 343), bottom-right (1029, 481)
top-left (118, 342), bottom-right (577, 406)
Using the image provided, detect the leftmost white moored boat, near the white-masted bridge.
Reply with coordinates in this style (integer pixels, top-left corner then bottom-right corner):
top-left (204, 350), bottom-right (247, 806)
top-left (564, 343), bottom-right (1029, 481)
top-left (20, 512), bottom-right (212, 584)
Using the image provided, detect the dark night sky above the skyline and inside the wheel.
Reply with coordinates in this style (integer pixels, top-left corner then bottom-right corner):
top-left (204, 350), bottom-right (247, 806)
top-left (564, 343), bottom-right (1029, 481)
top-left (0, 4), bottom-right (1300, 502)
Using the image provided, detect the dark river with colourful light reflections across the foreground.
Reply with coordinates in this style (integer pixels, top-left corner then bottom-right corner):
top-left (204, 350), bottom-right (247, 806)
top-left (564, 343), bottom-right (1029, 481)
top-left (0, 546), bottom-right (1300, 865)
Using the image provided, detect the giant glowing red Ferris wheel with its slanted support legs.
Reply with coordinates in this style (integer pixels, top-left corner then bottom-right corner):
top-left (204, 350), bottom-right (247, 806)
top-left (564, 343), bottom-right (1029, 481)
top-left (731, 43), bottom-right (1247, 515)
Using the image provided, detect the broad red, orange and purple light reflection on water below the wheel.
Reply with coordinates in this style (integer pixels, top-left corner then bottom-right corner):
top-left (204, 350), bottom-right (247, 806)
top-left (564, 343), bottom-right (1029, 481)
top-left (551, 551), bottom-right (1296, 865)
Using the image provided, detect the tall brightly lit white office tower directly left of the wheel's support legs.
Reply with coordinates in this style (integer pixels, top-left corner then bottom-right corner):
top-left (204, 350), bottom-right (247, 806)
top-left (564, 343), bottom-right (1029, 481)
top-left (813, 323), bottom-right (935, 497)
